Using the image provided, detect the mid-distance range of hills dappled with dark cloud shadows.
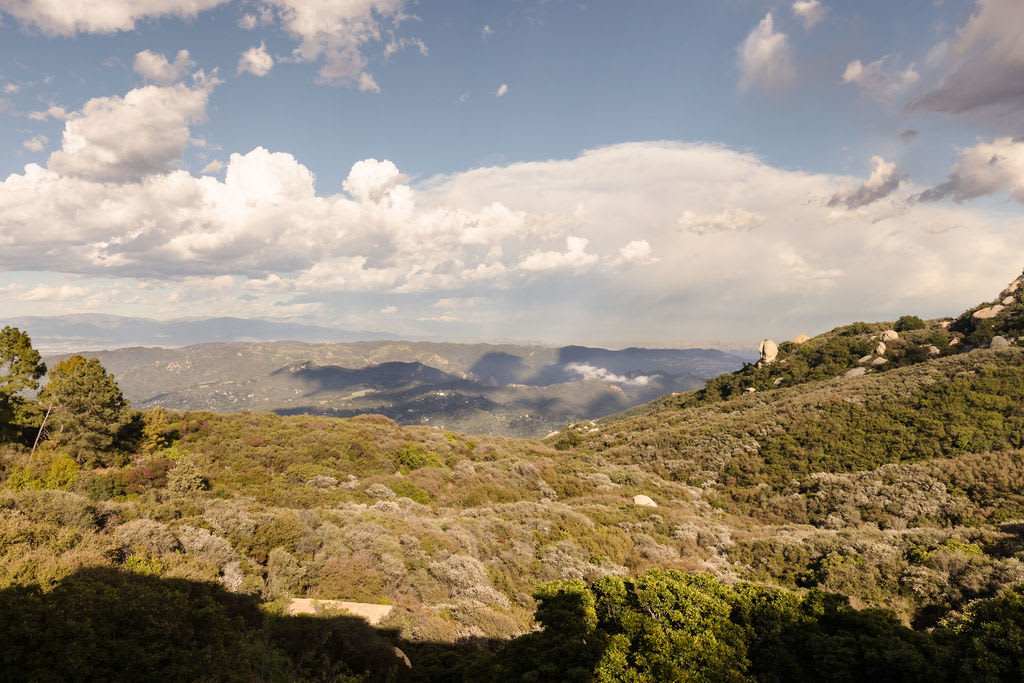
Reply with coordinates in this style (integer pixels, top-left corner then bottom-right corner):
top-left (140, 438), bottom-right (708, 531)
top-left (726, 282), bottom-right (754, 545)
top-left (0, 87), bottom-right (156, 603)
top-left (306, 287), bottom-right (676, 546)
top-left (52, 342), bottom-right (742, 436)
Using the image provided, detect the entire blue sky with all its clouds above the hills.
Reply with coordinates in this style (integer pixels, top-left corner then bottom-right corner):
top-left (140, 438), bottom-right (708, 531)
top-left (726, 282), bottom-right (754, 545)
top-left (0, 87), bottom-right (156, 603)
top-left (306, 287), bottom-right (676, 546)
top-left (0, 0), bottom-right (1024, 346)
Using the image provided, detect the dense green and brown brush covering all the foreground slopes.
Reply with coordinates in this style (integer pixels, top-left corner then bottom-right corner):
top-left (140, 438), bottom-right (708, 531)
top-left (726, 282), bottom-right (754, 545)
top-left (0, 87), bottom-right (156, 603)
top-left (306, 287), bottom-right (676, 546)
top-left (0, 274), bottom-right (1024, 682)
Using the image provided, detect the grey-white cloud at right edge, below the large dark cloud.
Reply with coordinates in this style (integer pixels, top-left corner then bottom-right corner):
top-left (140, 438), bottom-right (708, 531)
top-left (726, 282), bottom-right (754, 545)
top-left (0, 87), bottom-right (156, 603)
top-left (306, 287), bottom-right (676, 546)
top-left (919, 137), bottom-right (1024, 202)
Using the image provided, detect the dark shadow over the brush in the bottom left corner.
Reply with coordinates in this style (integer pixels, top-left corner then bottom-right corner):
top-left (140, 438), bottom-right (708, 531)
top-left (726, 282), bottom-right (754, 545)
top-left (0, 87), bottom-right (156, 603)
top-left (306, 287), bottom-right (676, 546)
top-left (0, 568), bottom-right (498, 682)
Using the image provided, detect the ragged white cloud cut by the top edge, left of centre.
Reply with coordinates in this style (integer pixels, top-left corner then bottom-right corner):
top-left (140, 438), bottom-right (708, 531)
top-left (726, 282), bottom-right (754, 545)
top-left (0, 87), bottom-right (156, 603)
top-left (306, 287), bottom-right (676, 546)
top-left (263, 0), bottom-right (413, 91)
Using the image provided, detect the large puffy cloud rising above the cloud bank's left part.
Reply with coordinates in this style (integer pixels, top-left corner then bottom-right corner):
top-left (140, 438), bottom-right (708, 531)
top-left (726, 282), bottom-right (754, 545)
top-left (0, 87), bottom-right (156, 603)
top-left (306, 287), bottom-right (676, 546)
top-left (48, 76), bottom-right (215, 182)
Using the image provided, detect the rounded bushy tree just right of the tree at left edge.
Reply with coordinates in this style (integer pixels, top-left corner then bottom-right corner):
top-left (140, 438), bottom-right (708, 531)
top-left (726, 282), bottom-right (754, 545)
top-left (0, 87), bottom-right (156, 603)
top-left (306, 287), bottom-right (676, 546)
top-left (40, 355), bottom-right (129, 462)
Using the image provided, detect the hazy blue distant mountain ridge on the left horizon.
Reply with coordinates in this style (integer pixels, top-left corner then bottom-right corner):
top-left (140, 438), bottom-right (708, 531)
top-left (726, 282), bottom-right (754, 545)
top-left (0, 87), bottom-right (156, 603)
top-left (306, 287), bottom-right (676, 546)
top-left (0, 313), bottom-right (398, 352)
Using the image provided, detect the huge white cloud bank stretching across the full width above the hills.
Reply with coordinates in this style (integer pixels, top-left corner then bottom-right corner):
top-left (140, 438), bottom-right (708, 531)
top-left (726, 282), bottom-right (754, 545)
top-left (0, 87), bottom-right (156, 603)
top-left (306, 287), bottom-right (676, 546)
top-left (0, 122), bottom-right (1024, 343)
